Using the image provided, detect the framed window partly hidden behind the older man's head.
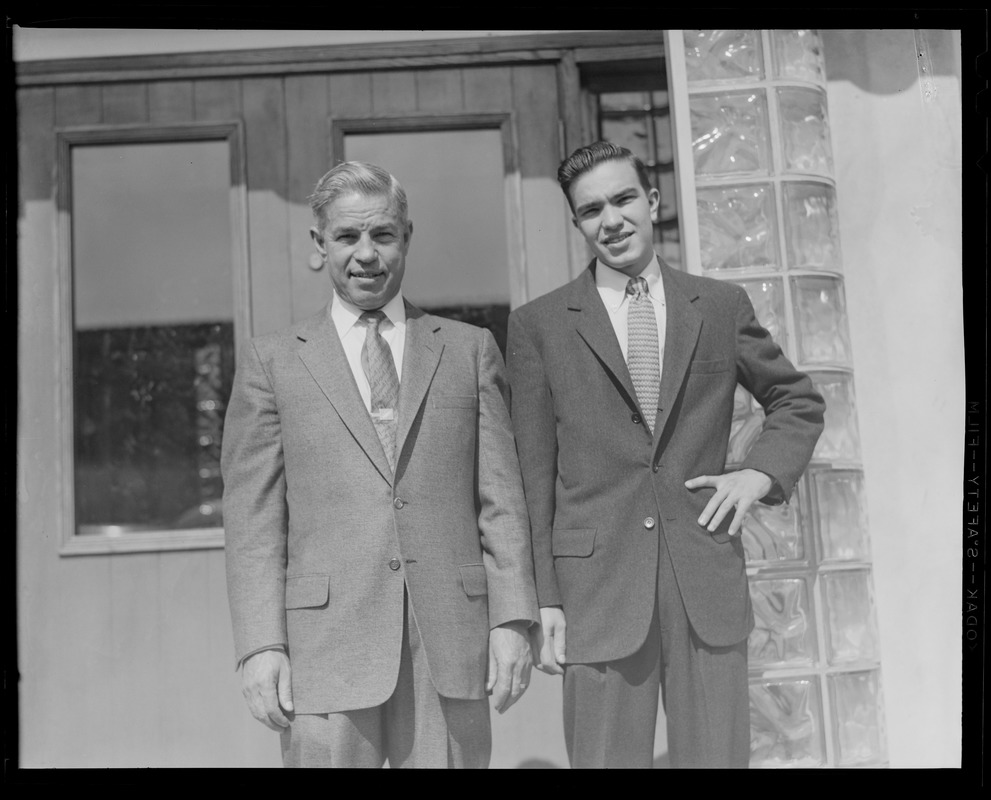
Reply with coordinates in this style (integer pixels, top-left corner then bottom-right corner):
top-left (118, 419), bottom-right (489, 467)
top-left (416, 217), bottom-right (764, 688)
top-left (335, 115), bottom-right (522, 354)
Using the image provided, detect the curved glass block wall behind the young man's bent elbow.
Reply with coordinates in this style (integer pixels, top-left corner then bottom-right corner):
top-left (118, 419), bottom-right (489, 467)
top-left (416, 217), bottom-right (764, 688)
top-left (671, 30), bottom-right (887, 767)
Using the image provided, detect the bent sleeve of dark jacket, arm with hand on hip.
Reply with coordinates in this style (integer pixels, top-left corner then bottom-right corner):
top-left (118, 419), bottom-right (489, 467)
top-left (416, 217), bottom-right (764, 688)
top-left (736, 288), bottom-right (826, 504)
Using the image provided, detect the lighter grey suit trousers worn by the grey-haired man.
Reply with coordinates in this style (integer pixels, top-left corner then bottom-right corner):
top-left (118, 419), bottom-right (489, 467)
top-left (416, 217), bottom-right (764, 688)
top-left (282, 596), bottom-right (492, 769)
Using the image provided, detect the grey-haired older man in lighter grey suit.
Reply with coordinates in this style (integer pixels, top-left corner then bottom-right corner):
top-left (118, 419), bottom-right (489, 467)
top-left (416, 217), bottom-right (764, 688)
top-left (223, 162), bottom-right (538, 767)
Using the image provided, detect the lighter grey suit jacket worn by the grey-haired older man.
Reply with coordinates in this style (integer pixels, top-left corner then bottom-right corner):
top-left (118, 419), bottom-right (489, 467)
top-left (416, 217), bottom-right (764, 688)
top-left (222, 305), bottom-right (538, 713)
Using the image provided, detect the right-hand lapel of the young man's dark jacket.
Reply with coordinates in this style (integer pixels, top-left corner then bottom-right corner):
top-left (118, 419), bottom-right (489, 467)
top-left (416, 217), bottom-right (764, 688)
top-left (654, 262), bottom-right (702, 444)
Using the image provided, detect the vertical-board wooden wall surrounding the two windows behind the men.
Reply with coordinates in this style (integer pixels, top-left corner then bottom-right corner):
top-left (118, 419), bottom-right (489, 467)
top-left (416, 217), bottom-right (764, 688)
top-left (17, 64), bottom-right (569, 767)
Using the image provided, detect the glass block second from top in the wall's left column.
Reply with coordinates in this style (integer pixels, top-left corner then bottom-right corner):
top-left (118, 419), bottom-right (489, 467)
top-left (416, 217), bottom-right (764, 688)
top-left (690, 91), bottom-right (770, 176)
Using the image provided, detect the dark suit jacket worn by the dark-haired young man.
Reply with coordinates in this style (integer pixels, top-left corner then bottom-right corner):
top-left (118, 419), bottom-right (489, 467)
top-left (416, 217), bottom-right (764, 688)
top-left (507, 262), bottom-right (824, 663)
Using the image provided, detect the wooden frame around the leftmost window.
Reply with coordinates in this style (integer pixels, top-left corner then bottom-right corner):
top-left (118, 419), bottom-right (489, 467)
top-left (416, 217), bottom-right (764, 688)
top-left (55, 120), bottom-right (251, 556)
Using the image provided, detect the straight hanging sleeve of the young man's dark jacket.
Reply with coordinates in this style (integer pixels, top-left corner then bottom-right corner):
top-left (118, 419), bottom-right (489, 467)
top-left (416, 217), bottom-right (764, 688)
top-left (506, 312), bottom-right (561, 607)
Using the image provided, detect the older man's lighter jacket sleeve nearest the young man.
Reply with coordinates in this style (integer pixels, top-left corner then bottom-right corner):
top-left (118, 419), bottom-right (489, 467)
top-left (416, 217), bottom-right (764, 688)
top-left (477, 330), bottom-right (540, 628)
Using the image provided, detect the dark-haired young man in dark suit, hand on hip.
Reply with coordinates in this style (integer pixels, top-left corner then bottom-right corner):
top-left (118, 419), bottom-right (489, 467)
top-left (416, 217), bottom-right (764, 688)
top-left (507, 142), bottom-right (824, 767)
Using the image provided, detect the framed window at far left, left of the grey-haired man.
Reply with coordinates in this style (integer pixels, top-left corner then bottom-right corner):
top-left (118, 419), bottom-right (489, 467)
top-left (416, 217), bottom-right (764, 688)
top-left (60, 126), bottom-right (246, 552)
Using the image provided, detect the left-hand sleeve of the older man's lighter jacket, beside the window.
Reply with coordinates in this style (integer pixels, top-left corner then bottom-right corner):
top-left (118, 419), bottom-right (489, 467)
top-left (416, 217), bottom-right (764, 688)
top-left (221, 342), bottom-right (289, 664)
